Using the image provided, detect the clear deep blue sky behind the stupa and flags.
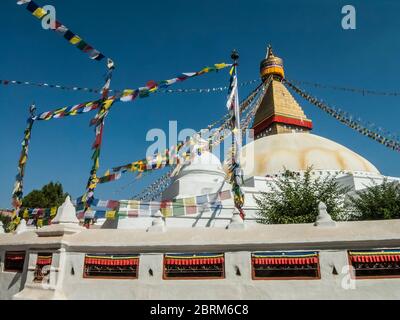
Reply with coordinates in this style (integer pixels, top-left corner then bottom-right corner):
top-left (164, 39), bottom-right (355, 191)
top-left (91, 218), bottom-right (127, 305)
top-left (0, 0), bottom-right (400, 207)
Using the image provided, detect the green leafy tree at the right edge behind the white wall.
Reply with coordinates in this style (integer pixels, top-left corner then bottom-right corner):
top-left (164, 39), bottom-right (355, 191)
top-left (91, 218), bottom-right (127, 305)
top-left (348, 179), bottom-right (400, 220)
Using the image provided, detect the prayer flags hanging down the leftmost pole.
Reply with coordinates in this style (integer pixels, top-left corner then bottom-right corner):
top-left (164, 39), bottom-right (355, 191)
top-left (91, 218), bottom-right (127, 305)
top-left (12, 104), bottom-right (36, 209)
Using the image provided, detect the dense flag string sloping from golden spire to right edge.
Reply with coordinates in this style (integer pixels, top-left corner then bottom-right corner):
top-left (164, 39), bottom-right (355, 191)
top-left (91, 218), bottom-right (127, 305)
top-left (284, 80), bottom-right (400, 151)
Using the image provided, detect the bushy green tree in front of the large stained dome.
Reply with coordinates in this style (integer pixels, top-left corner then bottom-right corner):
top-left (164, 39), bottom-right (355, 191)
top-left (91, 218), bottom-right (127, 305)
top-left (254, 167), bottom-right (349, 224)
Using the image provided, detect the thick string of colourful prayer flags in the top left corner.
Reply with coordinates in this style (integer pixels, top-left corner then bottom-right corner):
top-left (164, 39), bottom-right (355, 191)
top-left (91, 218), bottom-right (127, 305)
top-left (17, 0), bottom-right (105, 61)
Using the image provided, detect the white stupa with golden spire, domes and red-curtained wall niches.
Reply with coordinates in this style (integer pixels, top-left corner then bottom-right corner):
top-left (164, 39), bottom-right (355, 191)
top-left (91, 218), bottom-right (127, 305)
top-left (0, 47), bottom-right (400, 300)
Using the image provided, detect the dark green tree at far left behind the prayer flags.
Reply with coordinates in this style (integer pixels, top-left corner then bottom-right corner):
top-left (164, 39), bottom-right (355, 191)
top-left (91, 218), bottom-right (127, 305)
top-left (22, 182), bottom-right (68, 208)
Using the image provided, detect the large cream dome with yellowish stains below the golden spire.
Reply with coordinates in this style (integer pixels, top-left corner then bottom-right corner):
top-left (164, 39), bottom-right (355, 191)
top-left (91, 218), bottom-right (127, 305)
top-left (241, 132), bottom-right (379, 177)
